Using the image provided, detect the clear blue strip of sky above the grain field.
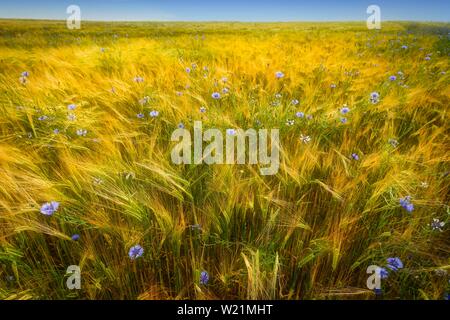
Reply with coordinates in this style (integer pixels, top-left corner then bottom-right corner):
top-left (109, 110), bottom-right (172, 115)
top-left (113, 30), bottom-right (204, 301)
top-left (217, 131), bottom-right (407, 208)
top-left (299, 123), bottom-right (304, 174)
top-left (0, 0), bottom-right (450, 22)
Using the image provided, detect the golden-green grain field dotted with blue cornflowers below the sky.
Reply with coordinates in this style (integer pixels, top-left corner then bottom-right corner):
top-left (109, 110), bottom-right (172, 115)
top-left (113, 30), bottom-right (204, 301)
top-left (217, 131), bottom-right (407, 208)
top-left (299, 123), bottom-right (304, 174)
top-left (0, 20), bottom-right (450, 299)
